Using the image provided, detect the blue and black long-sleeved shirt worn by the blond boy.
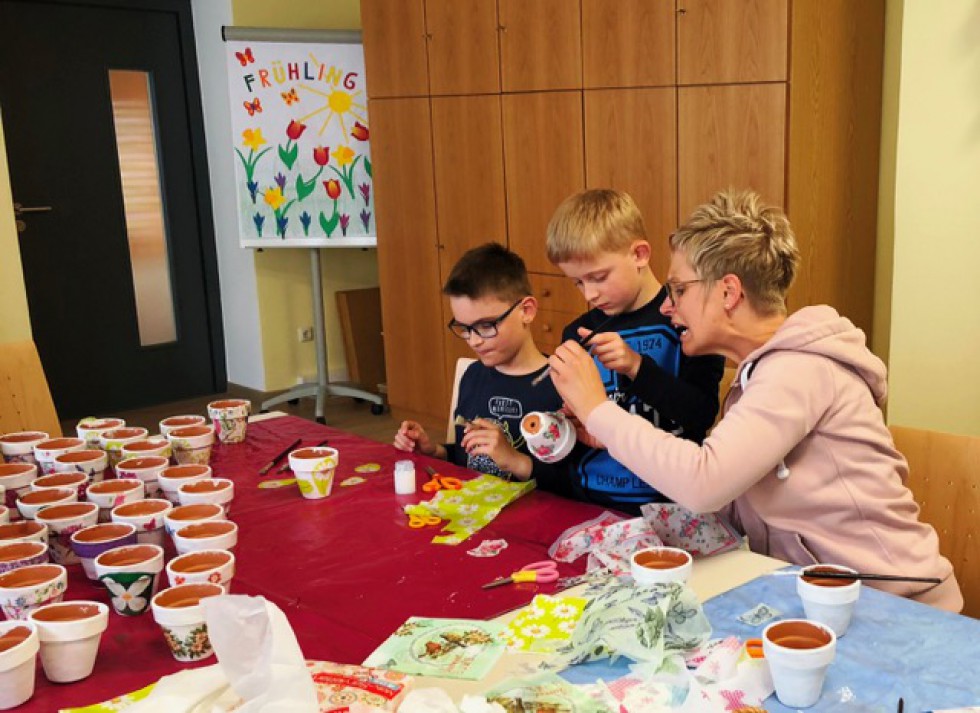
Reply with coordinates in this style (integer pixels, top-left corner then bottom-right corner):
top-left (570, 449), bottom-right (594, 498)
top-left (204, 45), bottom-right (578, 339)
top-left (562, 289), bottom-right (725, 514)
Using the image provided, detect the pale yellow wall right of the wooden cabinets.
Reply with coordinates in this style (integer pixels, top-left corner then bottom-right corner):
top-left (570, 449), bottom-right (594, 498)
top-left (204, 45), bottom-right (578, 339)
top-left (883, 0), bottom-right (980, 435)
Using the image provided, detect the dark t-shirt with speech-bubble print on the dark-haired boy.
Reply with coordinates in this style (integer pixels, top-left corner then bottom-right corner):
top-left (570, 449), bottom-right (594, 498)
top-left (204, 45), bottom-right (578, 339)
top-left (446, 361), bottom-right (564, 490)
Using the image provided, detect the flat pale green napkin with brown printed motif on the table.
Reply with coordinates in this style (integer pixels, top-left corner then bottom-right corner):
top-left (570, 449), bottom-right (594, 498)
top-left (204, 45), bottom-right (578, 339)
top-left (364, 617), bottom-right (504, 680)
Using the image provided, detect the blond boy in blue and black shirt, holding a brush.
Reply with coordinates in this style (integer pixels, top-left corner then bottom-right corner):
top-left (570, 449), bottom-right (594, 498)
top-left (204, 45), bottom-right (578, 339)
top-left (547, 190), bottom-right (725, 514)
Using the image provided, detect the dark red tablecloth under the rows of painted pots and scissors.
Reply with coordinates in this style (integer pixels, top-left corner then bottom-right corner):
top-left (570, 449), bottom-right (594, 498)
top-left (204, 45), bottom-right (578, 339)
top-left (30, 416), bottom-right (600, 711)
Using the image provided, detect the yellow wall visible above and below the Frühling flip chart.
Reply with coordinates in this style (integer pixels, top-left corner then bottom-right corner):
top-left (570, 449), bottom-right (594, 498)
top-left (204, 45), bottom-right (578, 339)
top-left (232, 0), bottom-right (378, 391)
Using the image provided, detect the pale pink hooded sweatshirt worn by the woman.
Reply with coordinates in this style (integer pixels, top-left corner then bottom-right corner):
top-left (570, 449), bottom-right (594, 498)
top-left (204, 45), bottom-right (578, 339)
top-left (586, 306), bottom-right (963, 612)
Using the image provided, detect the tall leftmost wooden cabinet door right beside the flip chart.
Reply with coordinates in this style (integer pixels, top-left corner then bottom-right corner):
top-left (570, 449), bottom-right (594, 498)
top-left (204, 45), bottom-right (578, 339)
top-left (369, 99), bottom-right (449, 418)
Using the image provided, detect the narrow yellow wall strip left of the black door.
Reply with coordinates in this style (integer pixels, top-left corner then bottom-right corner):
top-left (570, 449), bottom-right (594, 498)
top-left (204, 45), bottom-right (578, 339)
top-left (0, 112), bottom-right (31, 344)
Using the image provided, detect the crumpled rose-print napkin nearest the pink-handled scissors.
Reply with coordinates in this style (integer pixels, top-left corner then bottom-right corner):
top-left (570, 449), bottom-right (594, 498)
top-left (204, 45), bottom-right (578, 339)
top-left (548, 512), bottom-right (663, 577)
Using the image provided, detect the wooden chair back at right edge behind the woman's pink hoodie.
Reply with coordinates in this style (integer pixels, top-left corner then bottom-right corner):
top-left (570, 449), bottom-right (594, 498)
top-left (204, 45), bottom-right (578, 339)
top-left (890, 426), bottom-right (980, 618)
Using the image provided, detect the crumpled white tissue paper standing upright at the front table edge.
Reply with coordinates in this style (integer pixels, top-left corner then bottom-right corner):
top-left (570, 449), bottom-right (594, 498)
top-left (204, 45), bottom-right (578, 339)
top-left (127, 594), bottom-right (319, 713)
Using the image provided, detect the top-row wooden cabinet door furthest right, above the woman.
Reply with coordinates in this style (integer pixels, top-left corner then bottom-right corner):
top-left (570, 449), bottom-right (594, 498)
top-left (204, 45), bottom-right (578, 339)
top-left (677, 0), bottom-right (789, 84)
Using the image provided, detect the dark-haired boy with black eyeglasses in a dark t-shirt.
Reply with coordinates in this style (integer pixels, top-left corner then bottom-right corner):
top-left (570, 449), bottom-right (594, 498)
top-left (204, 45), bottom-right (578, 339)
top-left (394, 243), bottom-right (565, 490)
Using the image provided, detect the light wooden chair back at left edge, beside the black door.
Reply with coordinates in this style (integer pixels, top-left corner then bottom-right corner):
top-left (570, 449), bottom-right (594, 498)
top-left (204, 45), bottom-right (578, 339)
top-left (0, 341), bottom-right (61, 436)
